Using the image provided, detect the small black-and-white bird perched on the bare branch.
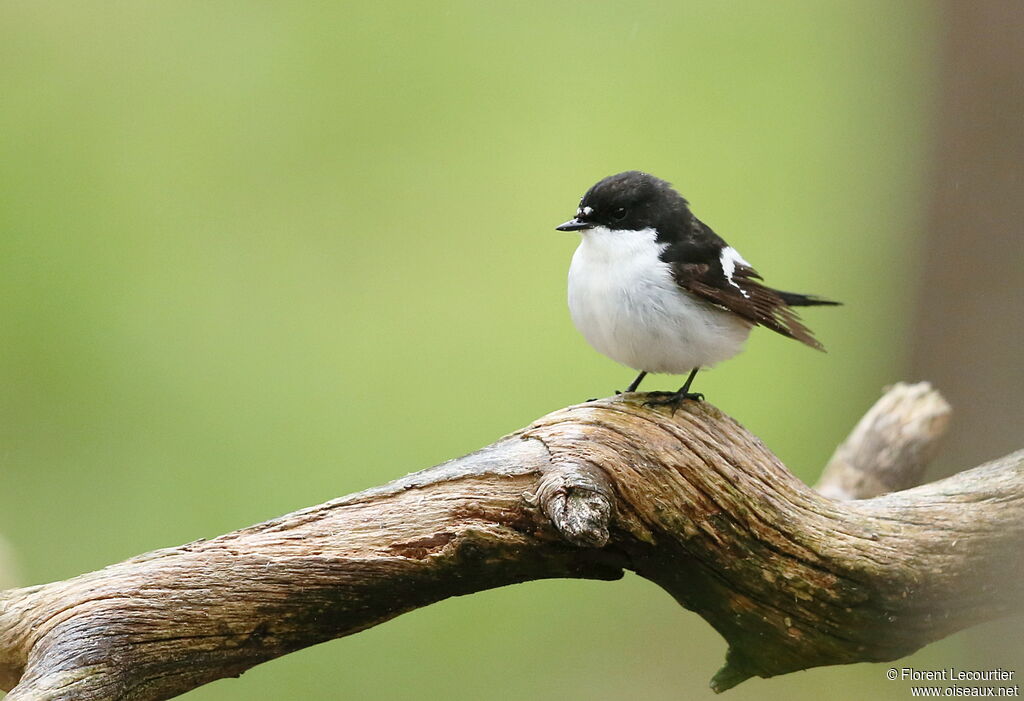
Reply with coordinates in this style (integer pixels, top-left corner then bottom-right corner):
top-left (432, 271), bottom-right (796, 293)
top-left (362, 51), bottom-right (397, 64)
top-left (556, 171), bottom-right (839, 403)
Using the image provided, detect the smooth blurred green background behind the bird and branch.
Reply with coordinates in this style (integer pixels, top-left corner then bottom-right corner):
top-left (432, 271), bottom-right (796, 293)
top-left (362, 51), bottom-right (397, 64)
top-left (0, 0), bottom-right (1011, 701)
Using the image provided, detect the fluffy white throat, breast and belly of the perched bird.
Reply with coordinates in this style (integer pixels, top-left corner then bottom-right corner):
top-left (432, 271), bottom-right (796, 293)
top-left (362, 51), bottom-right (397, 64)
top-left (569, 227), bottom-right (751, 375)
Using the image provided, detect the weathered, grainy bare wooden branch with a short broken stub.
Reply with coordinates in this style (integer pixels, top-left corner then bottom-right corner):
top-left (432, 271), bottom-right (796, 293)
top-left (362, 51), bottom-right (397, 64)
top-left (0, 386), bottom-right (1024, 701)
